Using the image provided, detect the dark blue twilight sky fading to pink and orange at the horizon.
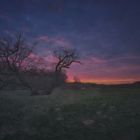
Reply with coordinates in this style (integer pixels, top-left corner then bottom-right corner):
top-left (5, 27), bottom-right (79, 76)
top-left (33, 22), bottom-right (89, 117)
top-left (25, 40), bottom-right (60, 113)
top-left (0, 0), bottom-right (140, 83)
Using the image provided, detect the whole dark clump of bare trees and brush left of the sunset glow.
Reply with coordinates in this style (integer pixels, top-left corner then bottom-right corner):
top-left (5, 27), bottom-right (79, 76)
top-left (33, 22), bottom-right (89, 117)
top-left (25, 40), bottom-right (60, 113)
top-left (0, 34), bottom-right (80, 95)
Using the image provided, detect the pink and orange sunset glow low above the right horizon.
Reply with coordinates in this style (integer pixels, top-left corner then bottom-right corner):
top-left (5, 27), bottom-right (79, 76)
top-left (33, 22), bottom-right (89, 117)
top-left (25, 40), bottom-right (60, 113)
top-left (67, 56), bottom-right (140, 84)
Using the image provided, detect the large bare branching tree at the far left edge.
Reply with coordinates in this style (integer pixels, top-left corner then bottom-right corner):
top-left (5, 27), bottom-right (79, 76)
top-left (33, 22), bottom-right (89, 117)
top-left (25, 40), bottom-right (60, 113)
top-left (0, 34), bottom-right (32, 89)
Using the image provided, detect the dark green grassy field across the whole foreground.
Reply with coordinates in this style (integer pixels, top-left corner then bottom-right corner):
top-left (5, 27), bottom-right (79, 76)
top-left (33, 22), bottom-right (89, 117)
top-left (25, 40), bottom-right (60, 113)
top-left (0, 87), bottom-right (140, 140)
